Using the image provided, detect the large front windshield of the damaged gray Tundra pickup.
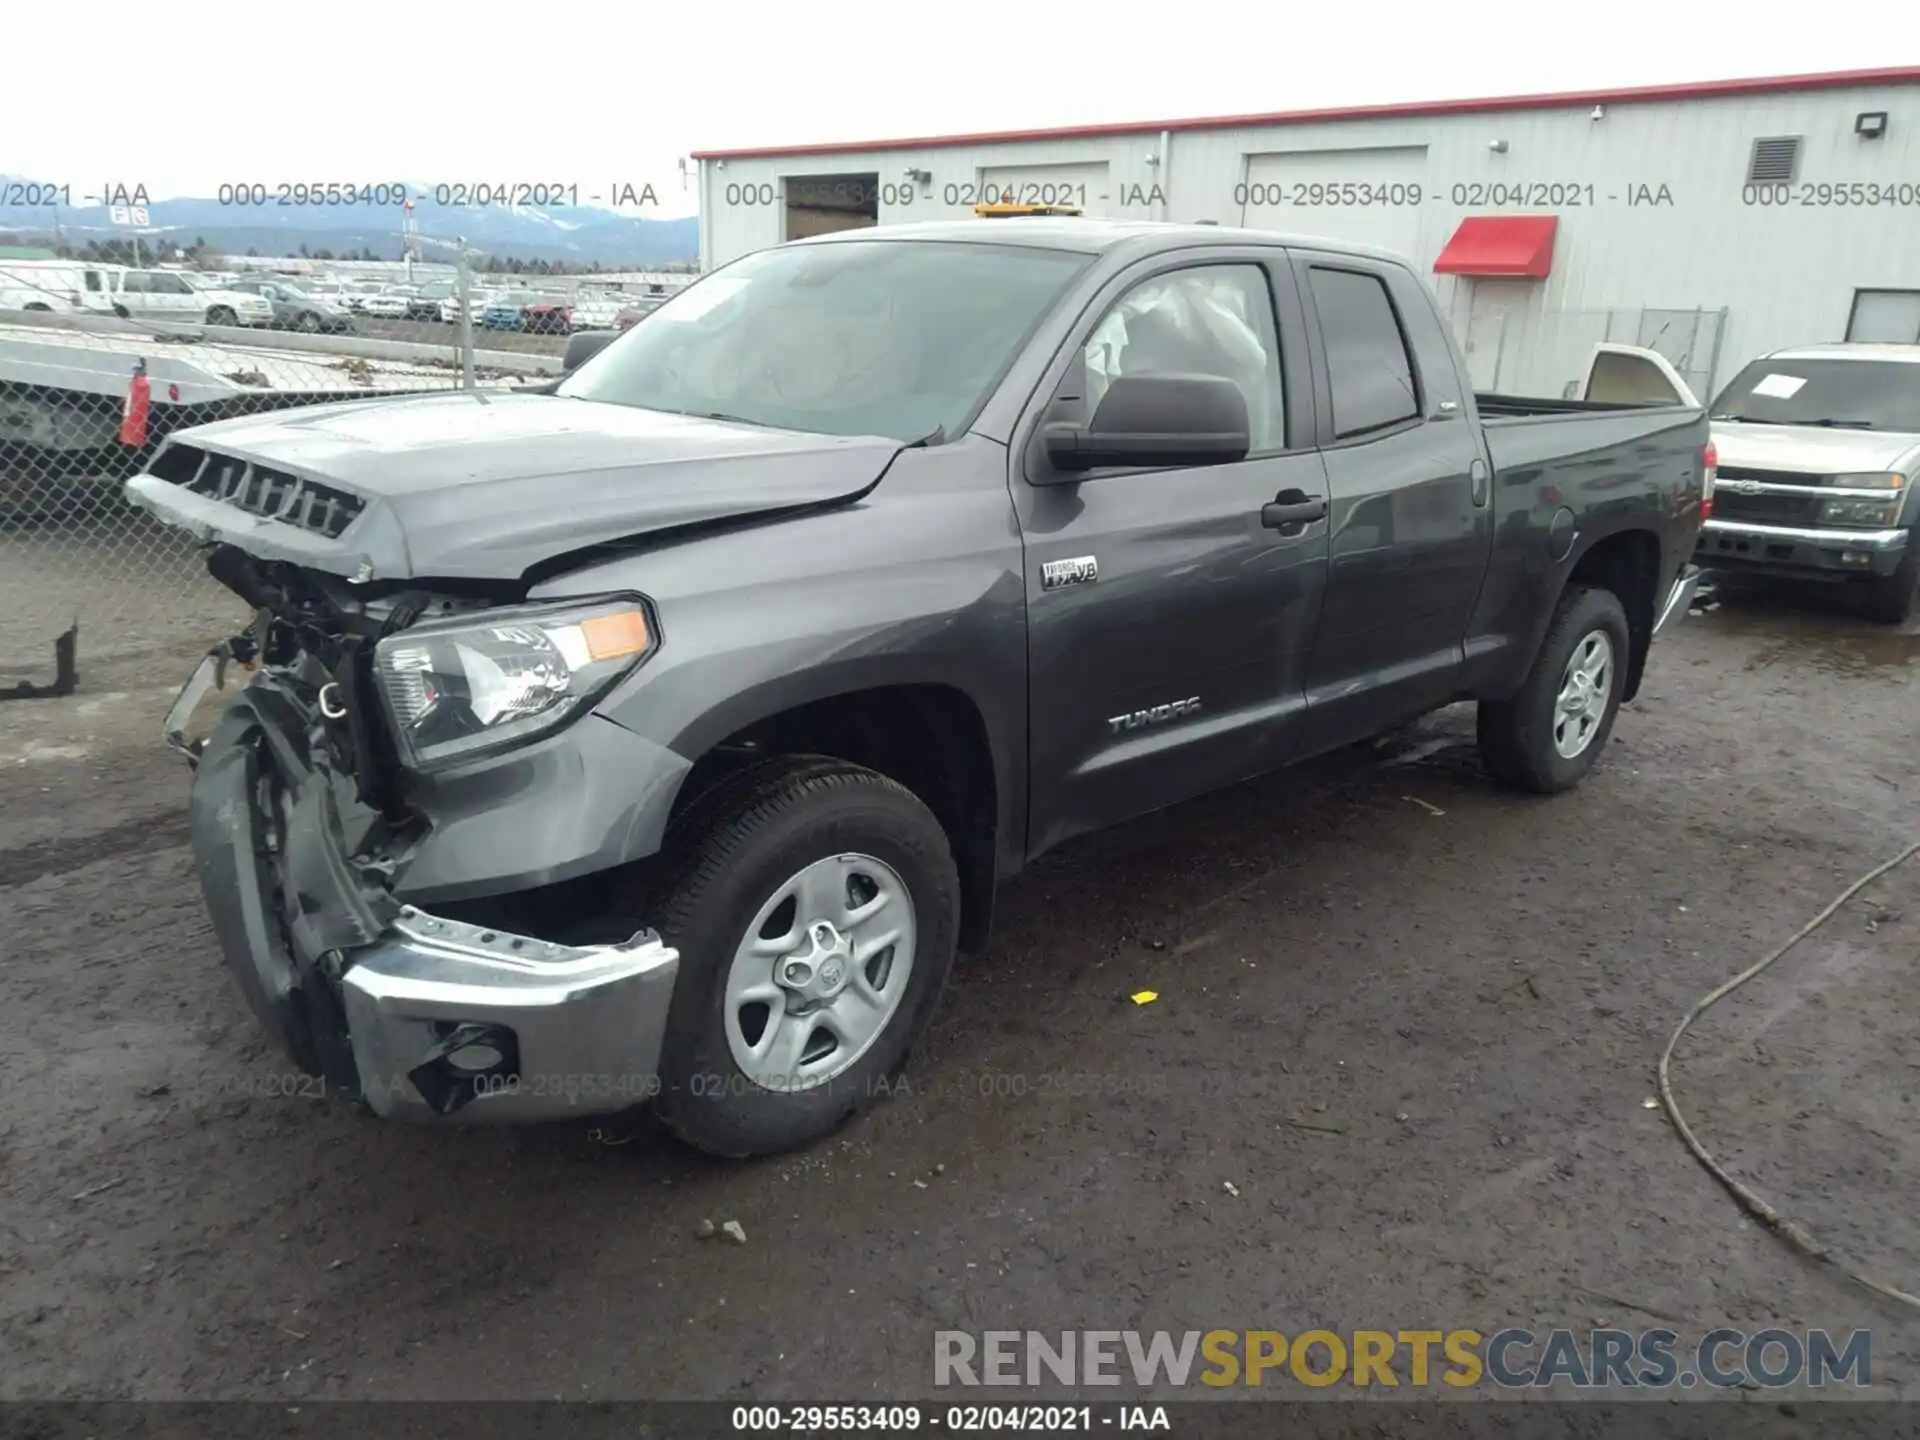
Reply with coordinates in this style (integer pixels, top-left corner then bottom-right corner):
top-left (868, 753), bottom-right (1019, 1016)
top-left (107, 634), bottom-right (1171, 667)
top-left (557, 240), bottom-right (1091, 442)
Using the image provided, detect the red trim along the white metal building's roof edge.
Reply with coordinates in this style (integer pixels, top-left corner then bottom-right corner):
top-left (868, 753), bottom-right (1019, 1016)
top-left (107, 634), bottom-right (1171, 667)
top-left (693, 65), bottom-right (1920, 159)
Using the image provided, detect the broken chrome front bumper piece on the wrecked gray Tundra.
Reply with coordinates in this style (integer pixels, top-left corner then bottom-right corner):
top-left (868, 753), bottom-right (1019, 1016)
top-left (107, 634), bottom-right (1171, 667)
top-left (340, 906), bottom-right (680, 1123)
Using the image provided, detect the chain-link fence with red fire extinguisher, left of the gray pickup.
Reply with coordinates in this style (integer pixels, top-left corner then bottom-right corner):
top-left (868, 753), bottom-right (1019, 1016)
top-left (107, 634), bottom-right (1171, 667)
top-left (0, 297), bottom-right (576, 695)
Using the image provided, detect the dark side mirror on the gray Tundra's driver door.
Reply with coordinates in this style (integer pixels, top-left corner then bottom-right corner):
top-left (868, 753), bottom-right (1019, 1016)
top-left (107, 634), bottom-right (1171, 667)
top-left (1043, 374), bottom-right (1254, 474)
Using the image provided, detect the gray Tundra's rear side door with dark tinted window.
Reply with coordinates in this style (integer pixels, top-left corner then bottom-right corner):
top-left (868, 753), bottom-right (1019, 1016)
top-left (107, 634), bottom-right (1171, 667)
top-left (1294, 252), bottom-right (1494, 749)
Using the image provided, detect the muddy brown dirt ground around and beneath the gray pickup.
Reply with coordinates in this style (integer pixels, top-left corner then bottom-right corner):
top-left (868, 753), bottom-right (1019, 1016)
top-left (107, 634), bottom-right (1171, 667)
top-left (0, 568), bottom-right (1920, 1400)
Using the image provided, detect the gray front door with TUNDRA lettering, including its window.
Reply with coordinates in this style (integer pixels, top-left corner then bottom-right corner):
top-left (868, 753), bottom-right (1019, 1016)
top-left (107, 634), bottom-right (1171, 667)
top-left (1012, 248), bottom-right (1327, 854)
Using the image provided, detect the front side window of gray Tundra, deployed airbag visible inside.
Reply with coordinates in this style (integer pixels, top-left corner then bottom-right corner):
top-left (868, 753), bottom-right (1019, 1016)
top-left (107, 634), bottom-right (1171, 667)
top-left (1083, 265), bottom-right (1286, 455)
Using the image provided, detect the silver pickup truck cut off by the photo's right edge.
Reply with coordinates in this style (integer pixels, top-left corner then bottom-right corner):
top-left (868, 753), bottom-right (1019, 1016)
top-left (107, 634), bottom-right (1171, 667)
top-left (1695, 344), bottom-right (1920, 624)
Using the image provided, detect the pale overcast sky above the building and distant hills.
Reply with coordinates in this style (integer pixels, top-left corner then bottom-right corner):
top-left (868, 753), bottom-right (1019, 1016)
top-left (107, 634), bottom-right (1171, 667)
top-left (0, 0), bottom-right (1889, 219)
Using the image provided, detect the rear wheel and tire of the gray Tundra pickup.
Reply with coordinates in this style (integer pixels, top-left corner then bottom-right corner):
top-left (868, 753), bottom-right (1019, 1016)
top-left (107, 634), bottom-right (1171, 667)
top-left (1478, 588), bottom-right (1632, 795)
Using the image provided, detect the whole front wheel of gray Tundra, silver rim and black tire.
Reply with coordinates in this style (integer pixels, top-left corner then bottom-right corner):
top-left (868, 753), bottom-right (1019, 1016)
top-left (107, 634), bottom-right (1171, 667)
top-left (653, 756), bottom-right (960, 1158)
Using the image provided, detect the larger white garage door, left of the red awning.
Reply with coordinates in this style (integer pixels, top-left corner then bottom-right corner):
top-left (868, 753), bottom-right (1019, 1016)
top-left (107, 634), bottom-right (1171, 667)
top-left (1233, 146), bottom-right (1432, 255)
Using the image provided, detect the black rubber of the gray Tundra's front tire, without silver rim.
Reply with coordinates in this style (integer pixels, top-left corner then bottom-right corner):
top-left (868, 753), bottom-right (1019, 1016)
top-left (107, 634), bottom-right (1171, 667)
top-left (647, 756), bottom-right (960, 1160)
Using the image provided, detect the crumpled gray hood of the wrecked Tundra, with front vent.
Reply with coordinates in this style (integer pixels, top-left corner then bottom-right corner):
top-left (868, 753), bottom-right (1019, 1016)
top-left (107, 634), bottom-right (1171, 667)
top-left (127, 392), bottom-right (900, 580)
